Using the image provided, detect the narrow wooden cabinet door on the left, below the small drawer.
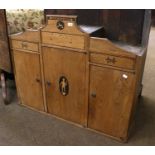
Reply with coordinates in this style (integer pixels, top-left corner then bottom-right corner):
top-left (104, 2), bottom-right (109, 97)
top-left (13, 51), bottom-right (44, 110)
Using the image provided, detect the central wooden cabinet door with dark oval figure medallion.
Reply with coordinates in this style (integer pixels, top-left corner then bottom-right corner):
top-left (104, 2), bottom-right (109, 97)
top-left (43, 47), bottom-right (87, 125)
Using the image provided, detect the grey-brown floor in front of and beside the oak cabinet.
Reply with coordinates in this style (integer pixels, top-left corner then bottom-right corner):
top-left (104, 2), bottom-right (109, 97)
top-left (0, 28), bottom-right (155, 145)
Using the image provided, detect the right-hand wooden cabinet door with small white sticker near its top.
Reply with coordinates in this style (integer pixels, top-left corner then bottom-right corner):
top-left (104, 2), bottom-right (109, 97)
top-left (88, 66), bottom-right (135, 139)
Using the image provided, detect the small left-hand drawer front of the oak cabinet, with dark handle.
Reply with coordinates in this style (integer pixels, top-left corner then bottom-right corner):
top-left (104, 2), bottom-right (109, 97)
top-left (12, 40), bottom-right (38, 52)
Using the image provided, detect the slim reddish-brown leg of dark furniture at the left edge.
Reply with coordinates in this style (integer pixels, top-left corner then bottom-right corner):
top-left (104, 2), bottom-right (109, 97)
top-left (0, 72), bottom-right (9, 105)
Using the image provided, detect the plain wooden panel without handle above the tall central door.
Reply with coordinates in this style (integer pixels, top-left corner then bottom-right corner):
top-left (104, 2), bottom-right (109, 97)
top-left (42, 32), bottom-right (84, 49)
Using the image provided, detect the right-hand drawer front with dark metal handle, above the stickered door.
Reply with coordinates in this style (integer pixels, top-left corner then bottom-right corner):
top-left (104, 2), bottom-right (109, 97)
top-left (90, 53), bottom-right (135, 69)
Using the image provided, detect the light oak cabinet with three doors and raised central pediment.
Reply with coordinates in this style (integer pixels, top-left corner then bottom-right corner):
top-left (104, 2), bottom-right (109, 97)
top-left (10, 16), bottom-right (146, 141)
